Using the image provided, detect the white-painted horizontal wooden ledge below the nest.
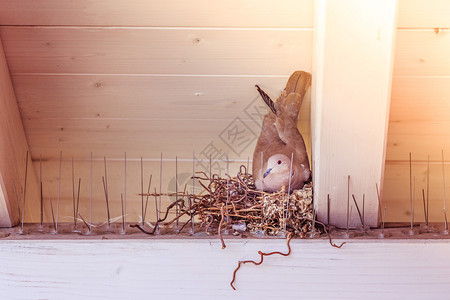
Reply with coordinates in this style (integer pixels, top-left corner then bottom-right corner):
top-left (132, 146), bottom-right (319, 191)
top-left (0, 238), bottom-right (450, 299)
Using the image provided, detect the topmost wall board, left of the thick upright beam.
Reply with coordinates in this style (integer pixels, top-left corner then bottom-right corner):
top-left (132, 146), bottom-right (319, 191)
top-left (0, 0), bottom-right (313, 28)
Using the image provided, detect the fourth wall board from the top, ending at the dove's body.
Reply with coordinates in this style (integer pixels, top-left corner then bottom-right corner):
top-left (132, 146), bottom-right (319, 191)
top-left (24, 119), bottom-right (259, 159)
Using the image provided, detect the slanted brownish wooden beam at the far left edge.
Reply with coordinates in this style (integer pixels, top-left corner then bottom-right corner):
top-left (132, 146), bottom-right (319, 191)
top-left (0, 37), bottom-right (39, 227)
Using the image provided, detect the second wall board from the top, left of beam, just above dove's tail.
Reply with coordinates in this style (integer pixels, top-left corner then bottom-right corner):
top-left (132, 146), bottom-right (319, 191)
top-left (0, 27), bottom-right (312, 75)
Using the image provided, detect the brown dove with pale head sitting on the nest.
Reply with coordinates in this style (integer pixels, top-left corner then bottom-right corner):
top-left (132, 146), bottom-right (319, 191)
top-left (252, 71), bottom-right (311, 192)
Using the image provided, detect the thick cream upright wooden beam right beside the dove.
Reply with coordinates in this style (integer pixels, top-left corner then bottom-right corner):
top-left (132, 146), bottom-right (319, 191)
top-left (311, 0), bottom-right (396, 227)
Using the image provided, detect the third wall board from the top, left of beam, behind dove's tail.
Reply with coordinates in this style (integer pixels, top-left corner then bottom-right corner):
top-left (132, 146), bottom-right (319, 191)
top-left (13, 74), bottom-right (290, 122)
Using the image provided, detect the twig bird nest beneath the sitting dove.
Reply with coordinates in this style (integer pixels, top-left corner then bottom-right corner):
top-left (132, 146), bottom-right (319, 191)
top-left (133, 166), bottom-right (314, 247)
